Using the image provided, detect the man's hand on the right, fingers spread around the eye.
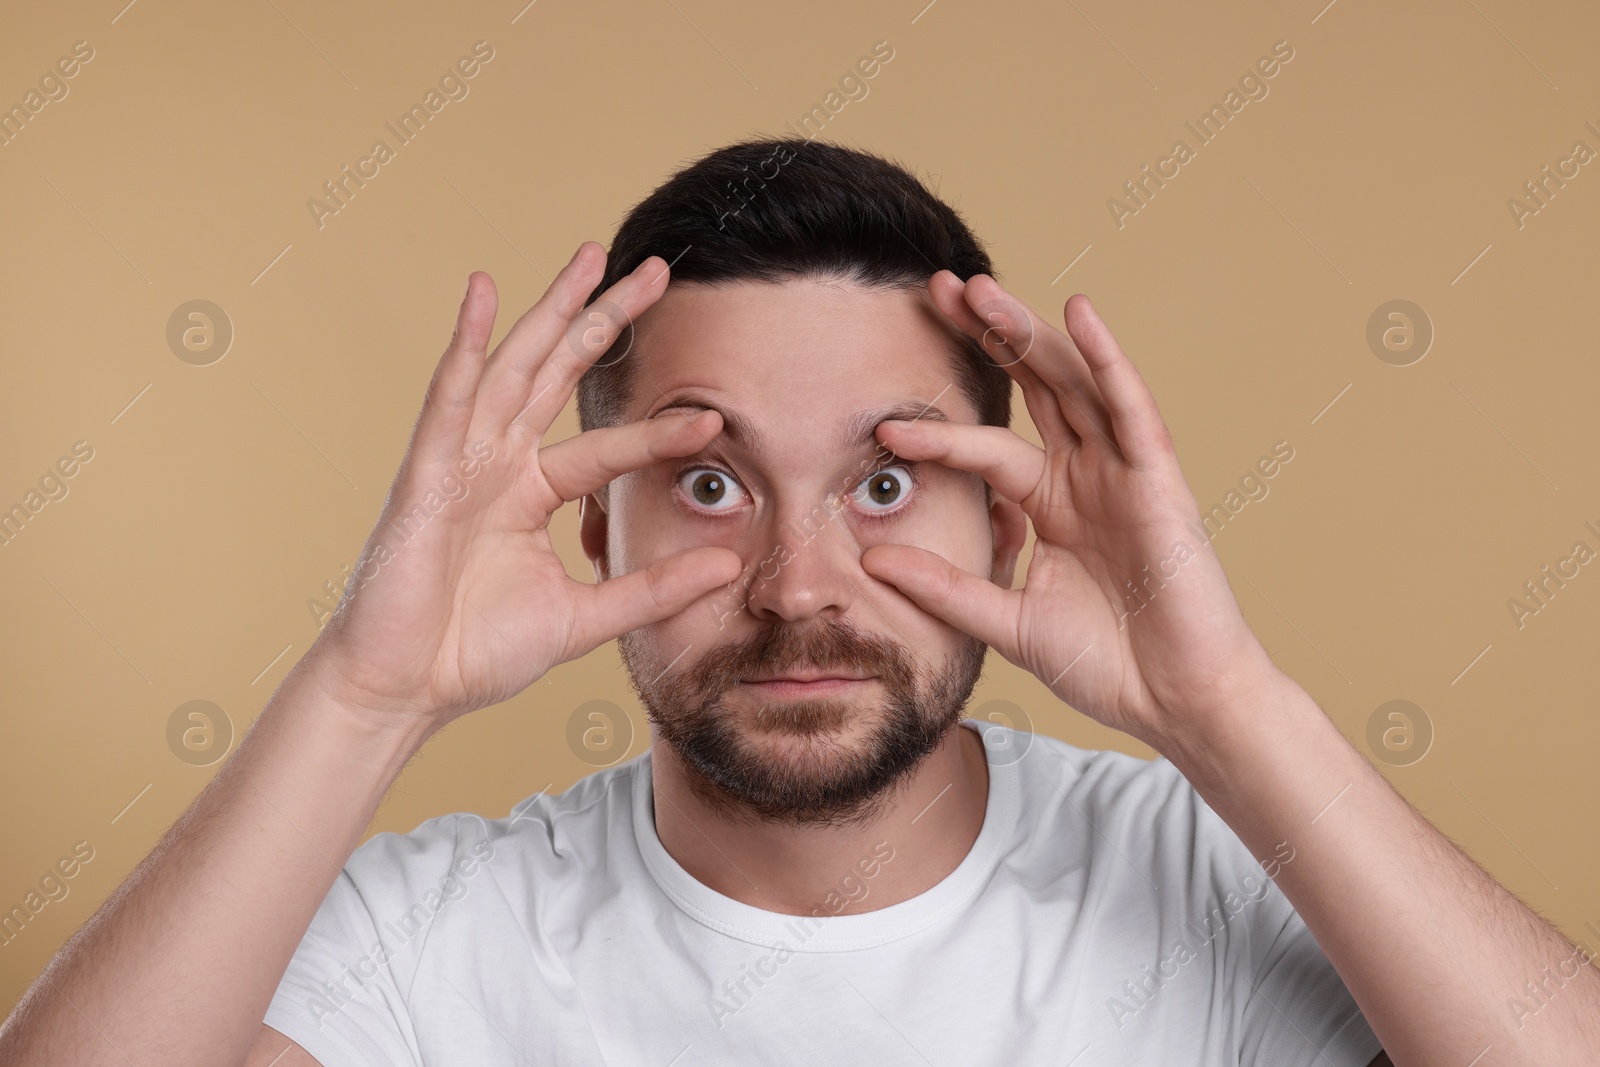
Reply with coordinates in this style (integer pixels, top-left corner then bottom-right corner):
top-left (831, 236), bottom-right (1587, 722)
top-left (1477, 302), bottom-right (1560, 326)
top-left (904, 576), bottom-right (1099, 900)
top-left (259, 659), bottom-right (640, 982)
top-left (861, 270), bottom-right (1277, 753)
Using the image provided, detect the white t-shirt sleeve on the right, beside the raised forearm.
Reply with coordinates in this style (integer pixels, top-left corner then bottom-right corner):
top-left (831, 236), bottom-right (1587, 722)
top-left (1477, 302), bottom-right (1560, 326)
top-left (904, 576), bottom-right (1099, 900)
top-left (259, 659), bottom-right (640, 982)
top-left (1190, 787), bottom-right (1382, 1067)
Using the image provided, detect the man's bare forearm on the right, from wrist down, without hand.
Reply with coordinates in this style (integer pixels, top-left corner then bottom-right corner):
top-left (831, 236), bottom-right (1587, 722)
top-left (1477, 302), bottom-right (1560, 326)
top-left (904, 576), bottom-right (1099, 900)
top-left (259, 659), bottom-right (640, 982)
top-left (1163, 672), bottom-right (1600, 1067)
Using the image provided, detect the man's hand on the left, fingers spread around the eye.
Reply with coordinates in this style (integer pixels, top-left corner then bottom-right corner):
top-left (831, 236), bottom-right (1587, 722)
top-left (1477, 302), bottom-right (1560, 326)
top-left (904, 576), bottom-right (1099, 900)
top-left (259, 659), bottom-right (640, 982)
top-left (312, 242), bottom-right (741, 729)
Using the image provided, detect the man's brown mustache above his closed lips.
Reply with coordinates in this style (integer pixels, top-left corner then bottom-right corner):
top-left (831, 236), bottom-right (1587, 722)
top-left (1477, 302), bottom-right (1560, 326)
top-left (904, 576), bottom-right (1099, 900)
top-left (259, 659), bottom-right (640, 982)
top-left (680, 622), bottom-right (915, 697)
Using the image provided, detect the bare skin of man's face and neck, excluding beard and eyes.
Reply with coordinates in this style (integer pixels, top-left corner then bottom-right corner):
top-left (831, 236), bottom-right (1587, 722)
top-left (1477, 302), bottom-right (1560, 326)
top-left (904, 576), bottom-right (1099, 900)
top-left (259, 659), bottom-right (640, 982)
top-left (581, 280), bottom-right (1026, 915)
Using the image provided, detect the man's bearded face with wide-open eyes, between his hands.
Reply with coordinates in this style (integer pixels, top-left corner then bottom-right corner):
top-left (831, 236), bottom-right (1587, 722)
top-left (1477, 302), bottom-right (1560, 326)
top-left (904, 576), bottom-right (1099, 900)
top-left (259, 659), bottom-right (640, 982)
top-left (584, 280), bottom-right (1018, 824)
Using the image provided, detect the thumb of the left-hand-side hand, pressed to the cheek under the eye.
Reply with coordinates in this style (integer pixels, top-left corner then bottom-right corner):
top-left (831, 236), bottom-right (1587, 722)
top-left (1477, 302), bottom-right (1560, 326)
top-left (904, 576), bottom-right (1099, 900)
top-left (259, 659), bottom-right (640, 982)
top-left (568, 545), bottom-right (744, 659)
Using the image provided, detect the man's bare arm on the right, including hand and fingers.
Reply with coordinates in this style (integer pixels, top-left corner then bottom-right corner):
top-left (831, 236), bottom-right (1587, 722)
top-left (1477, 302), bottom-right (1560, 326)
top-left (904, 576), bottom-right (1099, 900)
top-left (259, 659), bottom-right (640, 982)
top-left (862, 278), bottom-right (1600, 1067)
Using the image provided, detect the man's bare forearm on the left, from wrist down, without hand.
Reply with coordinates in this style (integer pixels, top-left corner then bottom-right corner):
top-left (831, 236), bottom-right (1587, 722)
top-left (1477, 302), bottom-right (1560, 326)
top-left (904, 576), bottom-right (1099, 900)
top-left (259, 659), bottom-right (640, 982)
top-left (0, 662), bottom-right (424, 1067)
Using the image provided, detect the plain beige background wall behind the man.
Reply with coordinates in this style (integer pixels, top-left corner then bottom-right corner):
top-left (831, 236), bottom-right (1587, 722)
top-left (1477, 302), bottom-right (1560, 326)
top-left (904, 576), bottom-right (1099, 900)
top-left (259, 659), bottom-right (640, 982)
top-left (0, 0), bottom-right (1600, 1009)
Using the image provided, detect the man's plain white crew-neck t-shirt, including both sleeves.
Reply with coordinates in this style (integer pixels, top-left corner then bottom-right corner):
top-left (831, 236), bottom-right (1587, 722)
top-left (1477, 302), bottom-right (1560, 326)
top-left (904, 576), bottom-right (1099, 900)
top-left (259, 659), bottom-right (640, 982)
top-left (266, 720), bottom-right (1379, 1067)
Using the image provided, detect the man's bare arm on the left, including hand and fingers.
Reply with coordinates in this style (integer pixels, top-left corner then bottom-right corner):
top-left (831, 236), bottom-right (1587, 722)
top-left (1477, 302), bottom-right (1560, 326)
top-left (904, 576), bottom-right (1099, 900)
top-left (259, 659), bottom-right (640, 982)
top-left (0, 242), bottom-right (739, 1067)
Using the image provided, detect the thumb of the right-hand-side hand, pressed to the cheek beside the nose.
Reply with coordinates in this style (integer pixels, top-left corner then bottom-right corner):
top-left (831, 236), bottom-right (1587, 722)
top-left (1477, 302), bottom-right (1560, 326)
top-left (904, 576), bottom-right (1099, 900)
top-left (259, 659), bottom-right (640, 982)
top-left (861, 544), bottom-right (1022, 659)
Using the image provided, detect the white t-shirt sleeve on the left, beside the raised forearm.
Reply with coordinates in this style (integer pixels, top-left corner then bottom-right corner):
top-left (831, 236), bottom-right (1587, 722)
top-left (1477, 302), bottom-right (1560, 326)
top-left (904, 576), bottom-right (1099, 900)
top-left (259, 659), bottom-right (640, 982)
top-left (264, 816), bottom-right (483, 1067)
